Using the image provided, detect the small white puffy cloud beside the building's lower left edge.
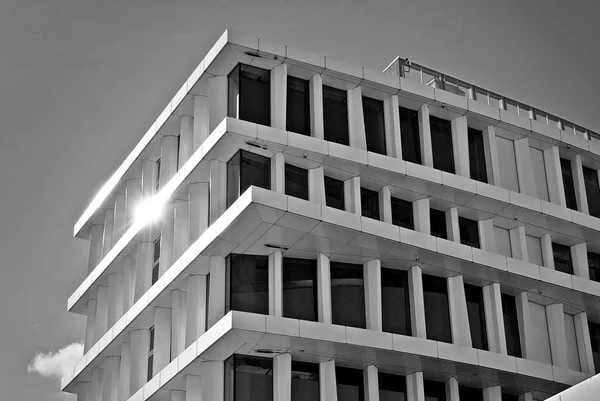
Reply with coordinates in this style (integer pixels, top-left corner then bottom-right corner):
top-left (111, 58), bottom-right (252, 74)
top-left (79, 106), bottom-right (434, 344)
top-left (27, 343), bottom-right (83, 379)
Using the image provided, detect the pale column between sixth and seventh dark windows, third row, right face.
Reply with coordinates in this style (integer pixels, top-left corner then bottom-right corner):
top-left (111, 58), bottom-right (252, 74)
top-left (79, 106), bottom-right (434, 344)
top-left (483, 283), bottom-right (508, 355)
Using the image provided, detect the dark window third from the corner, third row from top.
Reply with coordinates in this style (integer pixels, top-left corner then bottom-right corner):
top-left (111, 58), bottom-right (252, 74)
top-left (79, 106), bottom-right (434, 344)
top-left (330, 262), bottom-right (366, 329)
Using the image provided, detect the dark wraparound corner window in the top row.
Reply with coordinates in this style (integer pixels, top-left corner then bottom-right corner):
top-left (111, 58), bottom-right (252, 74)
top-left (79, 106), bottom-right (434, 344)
top-left (227, 64), bottom-right (271, 126)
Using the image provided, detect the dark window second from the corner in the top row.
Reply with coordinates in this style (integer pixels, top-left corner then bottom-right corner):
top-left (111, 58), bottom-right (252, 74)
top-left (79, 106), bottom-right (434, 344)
top-left (286, 75), bottom-right (310, 136)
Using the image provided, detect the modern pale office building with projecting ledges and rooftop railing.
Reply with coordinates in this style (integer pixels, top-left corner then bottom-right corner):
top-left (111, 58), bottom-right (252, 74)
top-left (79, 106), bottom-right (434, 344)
top-left (62, 31), bottom-right (600, 401)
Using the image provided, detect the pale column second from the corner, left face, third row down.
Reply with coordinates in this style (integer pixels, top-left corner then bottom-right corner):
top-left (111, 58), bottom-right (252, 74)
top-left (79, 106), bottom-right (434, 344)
top-left (185, 274), bottom-right (206, 348)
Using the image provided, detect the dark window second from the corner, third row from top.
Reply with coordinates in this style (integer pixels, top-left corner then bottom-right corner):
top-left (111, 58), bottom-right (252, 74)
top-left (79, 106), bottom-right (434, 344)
top-left (283, 258), bottom-right (317, 321)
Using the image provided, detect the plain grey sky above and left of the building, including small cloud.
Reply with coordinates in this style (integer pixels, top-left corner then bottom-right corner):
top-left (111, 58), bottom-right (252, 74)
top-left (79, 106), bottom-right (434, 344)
top-left (0, 0), bottom-right (600, 401)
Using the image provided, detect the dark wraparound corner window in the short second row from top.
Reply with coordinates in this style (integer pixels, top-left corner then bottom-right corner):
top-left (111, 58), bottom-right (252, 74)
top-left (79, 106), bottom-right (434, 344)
top-left (227, 150), bottom-right (271, 207)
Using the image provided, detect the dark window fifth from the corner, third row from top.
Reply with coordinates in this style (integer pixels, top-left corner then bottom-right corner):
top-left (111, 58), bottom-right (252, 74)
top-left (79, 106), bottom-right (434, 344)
top-left (423, 274), bottom-right (452, 343)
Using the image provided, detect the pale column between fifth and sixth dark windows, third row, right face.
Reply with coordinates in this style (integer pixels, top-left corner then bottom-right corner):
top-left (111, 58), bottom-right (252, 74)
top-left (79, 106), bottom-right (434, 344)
top-left (446, 276), bottom-right (472, 347)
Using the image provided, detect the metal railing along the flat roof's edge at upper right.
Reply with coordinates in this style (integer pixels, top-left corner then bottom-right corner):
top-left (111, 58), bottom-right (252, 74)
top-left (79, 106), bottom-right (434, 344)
top-left (383, 57), bottom-right (600, 141)
